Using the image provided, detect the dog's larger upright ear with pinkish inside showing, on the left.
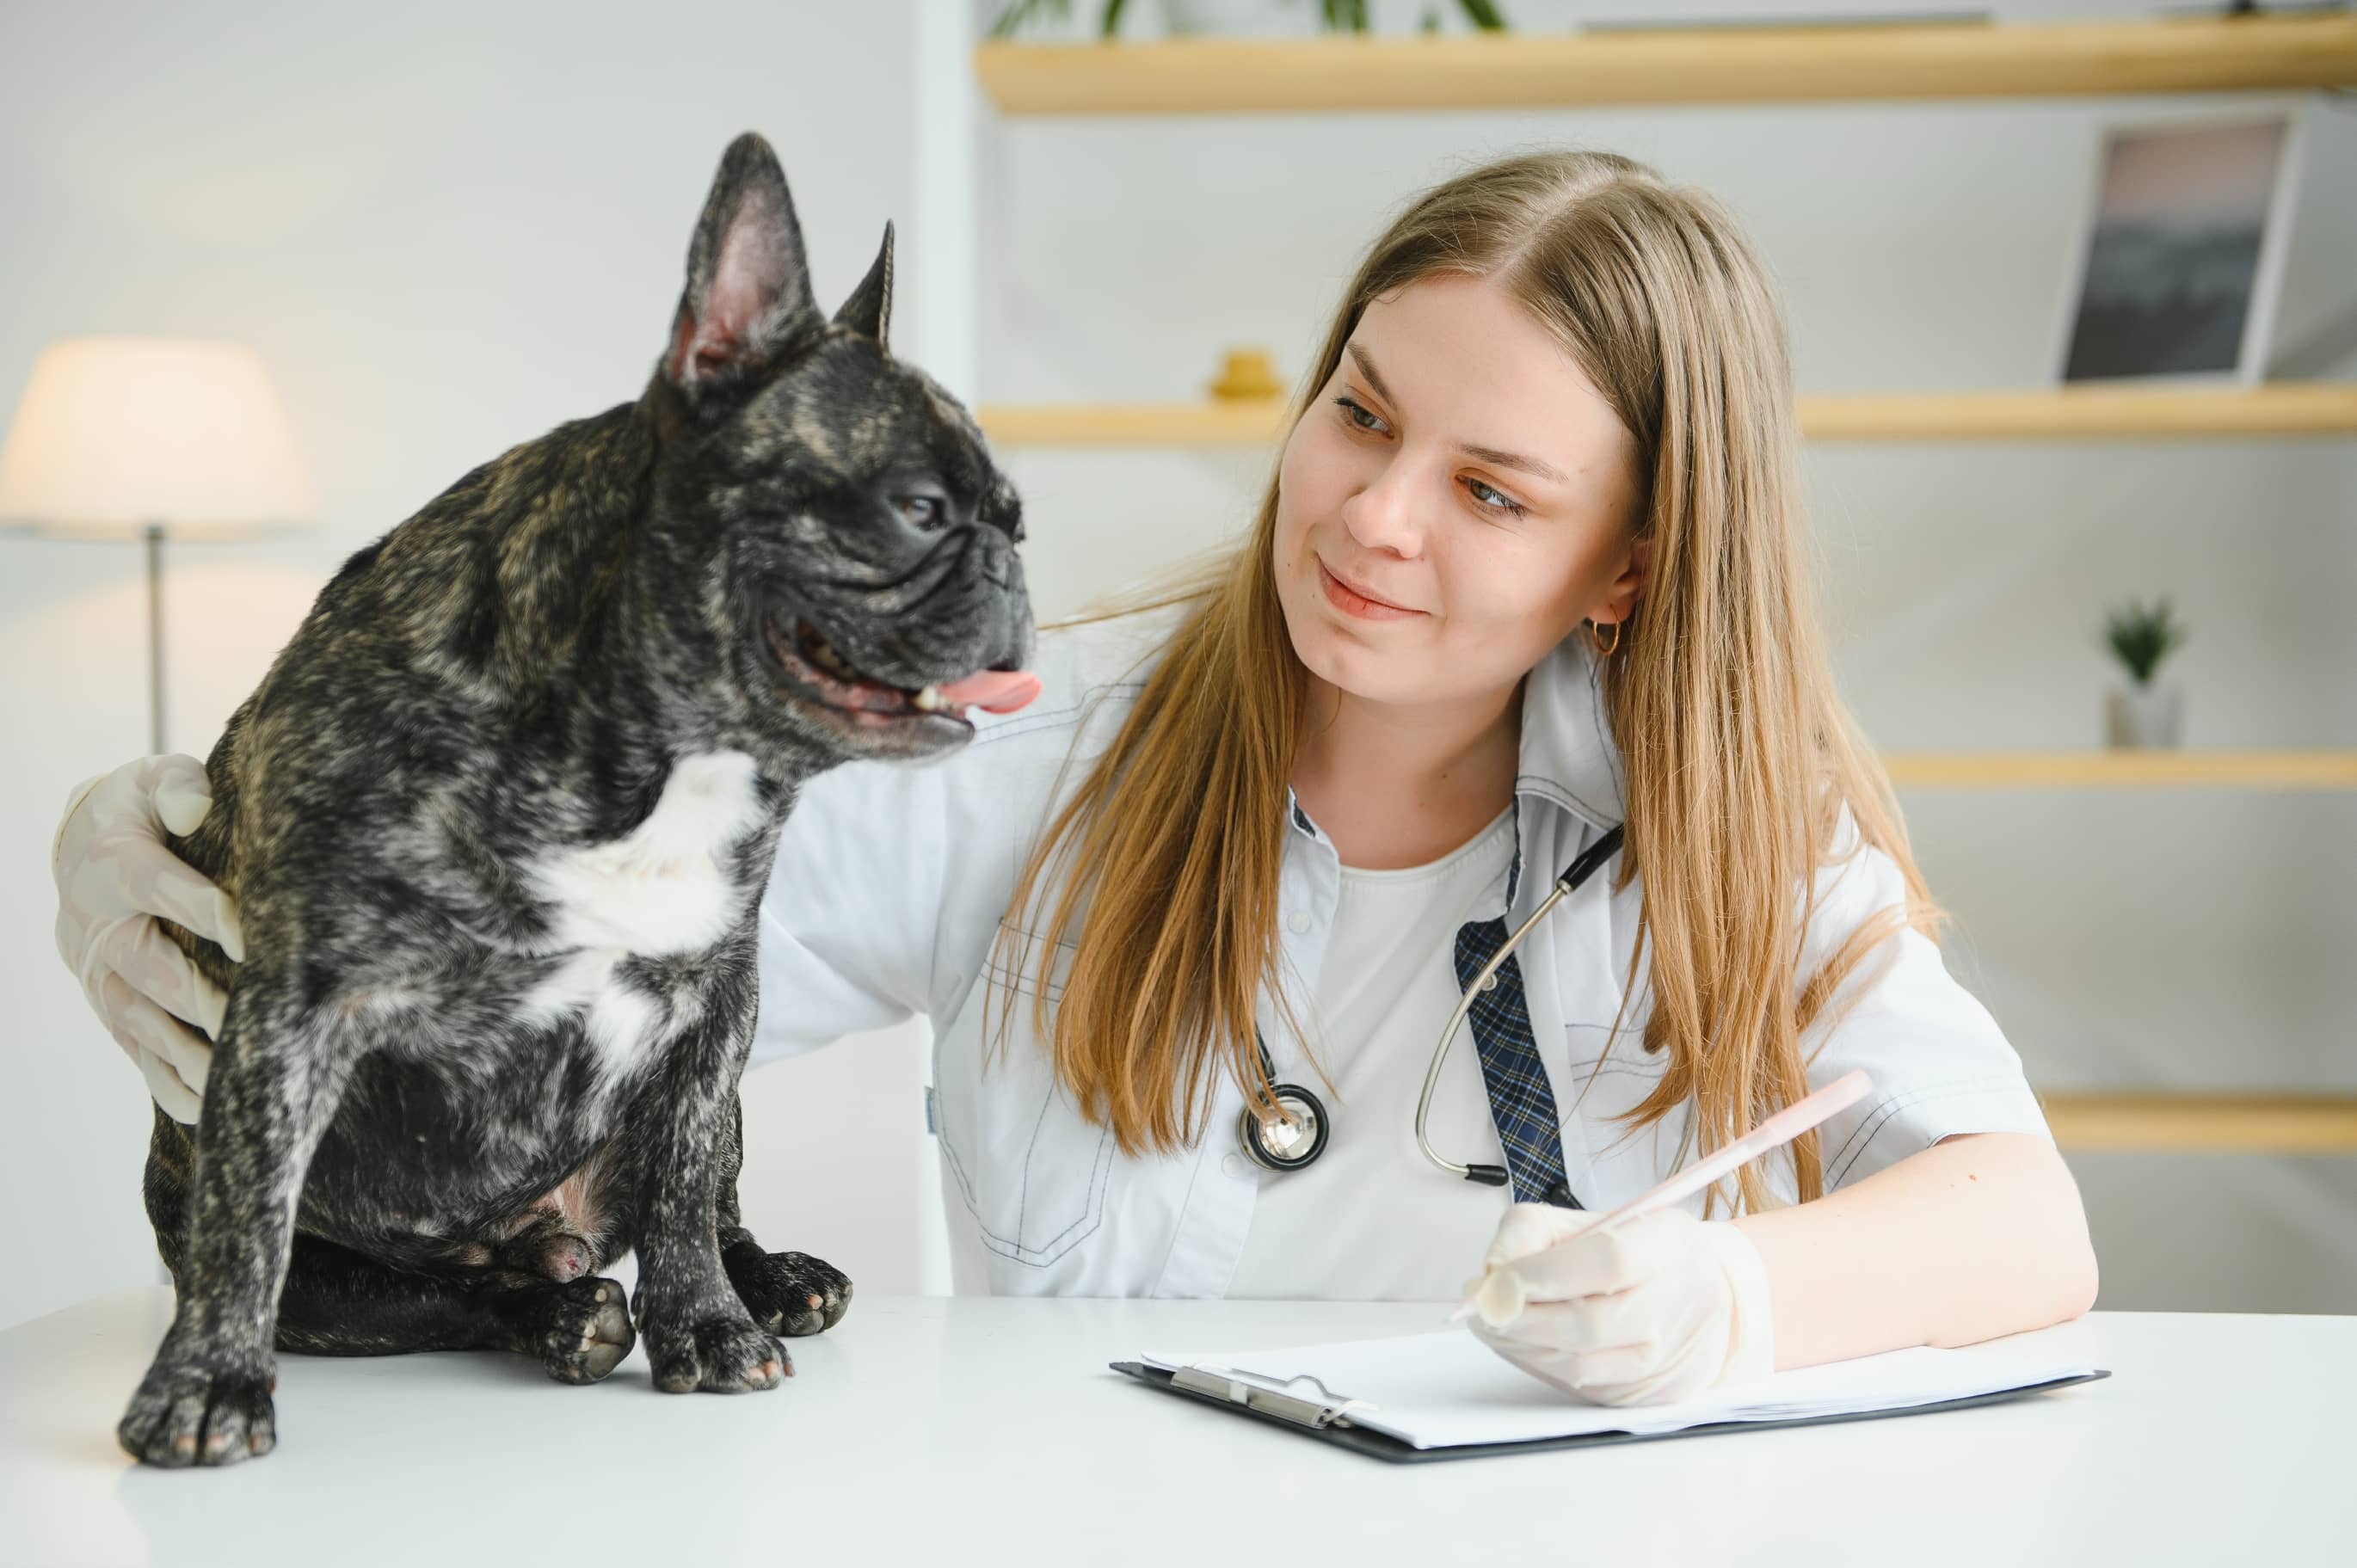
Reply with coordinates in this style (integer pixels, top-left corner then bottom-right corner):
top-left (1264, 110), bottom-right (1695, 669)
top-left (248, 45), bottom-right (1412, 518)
top-left (662, 132), bottom-right (818, 394)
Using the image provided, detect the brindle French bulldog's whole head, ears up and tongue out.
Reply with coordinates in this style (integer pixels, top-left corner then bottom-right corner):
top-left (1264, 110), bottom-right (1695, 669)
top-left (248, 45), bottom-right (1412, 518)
top-left (657, 137), bottom-right (1037, 759)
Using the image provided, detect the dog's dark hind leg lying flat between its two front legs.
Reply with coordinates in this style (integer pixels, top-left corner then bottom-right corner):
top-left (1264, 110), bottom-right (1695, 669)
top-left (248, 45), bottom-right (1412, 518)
top-left (278, 1235), bottom-right (637, 1384)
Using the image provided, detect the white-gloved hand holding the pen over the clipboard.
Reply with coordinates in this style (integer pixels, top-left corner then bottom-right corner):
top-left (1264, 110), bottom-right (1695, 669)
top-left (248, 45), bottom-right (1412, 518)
top-left (1468, 1202), bottom-right (1775, 1405)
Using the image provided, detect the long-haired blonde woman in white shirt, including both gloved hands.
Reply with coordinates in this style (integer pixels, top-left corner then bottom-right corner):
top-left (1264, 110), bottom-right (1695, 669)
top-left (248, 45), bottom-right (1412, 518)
top-left (57, 153), bottom-right (2095, 1403)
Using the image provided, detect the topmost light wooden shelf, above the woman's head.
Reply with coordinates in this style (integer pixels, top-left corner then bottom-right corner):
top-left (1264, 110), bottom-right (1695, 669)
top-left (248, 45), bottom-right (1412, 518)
top-left (974, 14), bottom-right (2357, 115)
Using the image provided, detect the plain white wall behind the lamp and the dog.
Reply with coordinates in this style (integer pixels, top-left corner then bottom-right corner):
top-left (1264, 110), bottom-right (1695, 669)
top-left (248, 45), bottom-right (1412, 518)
top-left (0, 0), bottom-right (933, 1325)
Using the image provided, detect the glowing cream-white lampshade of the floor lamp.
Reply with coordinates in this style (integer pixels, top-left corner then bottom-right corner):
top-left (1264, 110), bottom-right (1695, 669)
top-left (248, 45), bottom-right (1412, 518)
top-left (0, 337), bottom-right (311, 538)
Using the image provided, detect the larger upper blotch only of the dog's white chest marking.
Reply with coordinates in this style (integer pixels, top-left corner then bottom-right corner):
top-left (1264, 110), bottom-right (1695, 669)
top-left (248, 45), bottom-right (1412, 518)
top-left (531, 752), bottom-right (761, 955)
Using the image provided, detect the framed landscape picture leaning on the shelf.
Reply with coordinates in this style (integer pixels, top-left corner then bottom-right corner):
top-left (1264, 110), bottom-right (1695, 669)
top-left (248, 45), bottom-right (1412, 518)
top-left (2060, 114), bottom-right (2299, 384)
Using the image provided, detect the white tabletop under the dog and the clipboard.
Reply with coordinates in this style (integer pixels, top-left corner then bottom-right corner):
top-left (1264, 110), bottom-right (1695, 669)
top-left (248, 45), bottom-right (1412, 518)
top-left (0, 1290), bottom-right (2357, 1568)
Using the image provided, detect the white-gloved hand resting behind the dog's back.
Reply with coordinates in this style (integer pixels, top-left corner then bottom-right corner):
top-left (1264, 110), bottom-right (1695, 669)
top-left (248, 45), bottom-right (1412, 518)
top-left (50, 757), bottom-right (245, 1122)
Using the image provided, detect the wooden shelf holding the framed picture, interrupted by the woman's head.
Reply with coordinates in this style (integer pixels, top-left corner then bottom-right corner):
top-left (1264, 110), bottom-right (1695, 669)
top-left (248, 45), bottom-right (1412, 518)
top-left (981, 382), bottom-right (2357, 446)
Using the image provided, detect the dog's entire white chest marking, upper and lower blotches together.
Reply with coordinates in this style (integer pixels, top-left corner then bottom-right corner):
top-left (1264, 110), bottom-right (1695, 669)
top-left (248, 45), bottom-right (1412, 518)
top-left (523, 752), bottom-right (761, 1075)
